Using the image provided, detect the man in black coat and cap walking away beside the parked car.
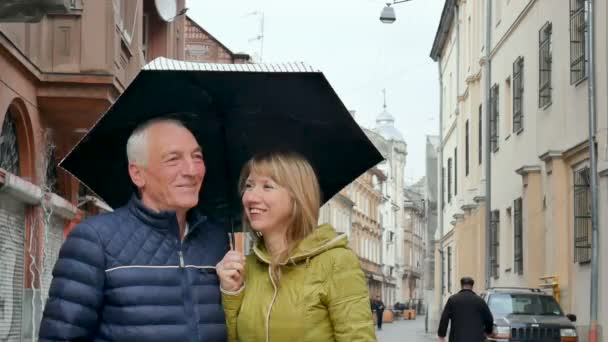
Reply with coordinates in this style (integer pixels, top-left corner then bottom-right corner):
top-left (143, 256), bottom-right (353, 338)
top-left (437, 277), bottom-right (494, 342)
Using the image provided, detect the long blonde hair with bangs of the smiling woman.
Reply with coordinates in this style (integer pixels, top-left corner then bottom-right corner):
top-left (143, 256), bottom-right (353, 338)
top-left (239, 152), bottom-right (321, 284)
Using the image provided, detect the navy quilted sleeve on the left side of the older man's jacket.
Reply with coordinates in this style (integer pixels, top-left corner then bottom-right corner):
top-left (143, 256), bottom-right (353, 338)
top-left (39, 222), bottom-right (105, 341)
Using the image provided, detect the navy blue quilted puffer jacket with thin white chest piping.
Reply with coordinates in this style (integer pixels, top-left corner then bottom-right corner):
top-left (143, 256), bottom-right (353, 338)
top-left (40, 197), bottom-right (228, 342)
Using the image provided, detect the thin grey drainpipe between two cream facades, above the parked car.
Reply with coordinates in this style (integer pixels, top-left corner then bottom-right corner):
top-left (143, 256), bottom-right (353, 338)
top-left (484, 1), bottom-right (492, 289)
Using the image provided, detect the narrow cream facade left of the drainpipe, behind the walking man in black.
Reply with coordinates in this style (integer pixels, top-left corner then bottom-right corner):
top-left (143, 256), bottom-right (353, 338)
top-left (428, 1), bottom-right (485, 330)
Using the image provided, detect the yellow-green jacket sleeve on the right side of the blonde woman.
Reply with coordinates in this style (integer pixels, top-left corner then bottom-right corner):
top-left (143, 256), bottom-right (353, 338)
top-left (325, 249), bottom-right (376, 342)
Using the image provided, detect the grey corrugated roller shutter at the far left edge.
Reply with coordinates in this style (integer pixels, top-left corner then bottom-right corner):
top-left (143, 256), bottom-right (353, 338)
top-left (0, 194), bottom-right (25, 341)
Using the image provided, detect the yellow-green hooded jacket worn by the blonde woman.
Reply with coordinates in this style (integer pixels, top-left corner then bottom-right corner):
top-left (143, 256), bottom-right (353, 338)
top-left (222, 225), bottom-right (376, 342)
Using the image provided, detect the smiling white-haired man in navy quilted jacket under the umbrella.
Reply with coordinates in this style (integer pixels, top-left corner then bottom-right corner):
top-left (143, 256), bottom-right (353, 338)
top-left (40, 119), bottom-right (228, 342)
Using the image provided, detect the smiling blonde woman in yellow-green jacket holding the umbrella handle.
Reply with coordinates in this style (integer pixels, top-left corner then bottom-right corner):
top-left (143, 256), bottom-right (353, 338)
top-left (217, 153), bottom-right (376, 342)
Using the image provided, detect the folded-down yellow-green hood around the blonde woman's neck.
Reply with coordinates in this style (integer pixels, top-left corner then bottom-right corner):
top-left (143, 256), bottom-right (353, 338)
top-left (253, 224), bottom-right (348, 265)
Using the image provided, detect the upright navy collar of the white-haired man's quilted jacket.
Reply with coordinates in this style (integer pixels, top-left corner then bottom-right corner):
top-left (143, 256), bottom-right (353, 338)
top-left (127, 194), bottom-right (207, 236)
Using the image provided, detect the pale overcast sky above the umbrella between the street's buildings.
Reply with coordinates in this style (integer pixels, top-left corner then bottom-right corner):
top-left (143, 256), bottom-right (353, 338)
top-left (187, 0), bottom-right (444, 183)
